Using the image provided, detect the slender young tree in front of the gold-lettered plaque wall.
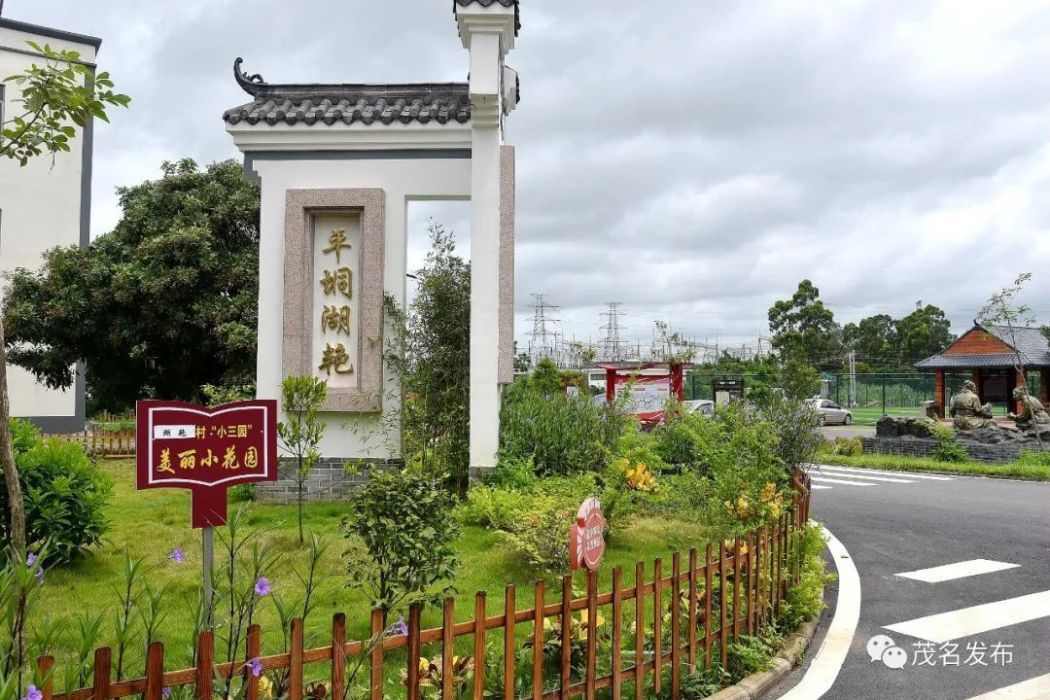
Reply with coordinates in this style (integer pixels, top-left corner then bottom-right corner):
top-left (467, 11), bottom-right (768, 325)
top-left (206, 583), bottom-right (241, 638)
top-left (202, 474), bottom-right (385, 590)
top-left (277, 376), bottom-right (328, 545)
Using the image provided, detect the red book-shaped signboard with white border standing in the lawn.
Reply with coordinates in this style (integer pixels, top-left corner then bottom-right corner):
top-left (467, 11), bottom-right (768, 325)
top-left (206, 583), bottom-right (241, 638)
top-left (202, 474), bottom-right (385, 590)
top-left (135, 400), bottom-right (277, 528)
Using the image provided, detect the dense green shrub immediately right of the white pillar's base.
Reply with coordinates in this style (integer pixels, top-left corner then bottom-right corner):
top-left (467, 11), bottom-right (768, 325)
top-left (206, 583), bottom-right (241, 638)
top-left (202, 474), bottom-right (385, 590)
top-left (500, 387), bottom-right (626, 474)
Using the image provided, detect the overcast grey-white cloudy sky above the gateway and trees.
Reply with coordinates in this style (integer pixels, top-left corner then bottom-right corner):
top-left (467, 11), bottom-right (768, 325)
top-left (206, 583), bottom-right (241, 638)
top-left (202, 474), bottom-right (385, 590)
top-left (4, 0), bottom-right (1050, 350)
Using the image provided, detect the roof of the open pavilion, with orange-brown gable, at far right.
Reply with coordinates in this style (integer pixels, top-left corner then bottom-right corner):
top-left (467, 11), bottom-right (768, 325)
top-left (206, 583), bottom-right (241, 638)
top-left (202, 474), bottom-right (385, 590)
top-left (916, 323), bottom-right (1050, 369)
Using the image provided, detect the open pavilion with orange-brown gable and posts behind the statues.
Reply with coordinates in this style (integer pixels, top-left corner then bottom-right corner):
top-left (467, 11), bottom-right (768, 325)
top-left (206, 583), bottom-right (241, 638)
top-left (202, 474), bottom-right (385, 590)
top-left (916, 321), bottom-right (1050, 418)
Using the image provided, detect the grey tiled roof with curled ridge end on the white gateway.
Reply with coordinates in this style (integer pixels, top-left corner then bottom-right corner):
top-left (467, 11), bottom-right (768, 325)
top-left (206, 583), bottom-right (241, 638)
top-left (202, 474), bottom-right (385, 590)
top-left (223, 58), bottom-right (470, 125)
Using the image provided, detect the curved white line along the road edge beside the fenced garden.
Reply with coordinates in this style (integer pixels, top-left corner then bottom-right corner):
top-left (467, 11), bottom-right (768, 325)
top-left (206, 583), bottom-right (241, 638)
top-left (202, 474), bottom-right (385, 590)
top-left (780, 526), bottom-right (860, 700)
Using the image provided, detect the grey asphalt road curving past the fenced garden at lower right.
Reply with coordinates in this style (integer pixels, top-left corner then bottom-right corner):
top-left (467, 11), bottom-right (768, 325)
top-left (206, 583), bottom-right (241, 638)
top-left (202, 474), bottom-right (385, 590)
top-left (772, 467), bottom-right (1050, 700)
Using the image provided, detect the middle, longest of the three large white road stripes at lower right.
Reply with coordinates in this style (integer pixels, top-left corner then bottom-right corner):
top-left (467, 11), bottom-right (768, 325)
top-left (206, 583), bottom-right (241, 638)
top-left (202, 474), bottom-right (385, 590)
top-left (885, 591), bottom-right (1050, 644)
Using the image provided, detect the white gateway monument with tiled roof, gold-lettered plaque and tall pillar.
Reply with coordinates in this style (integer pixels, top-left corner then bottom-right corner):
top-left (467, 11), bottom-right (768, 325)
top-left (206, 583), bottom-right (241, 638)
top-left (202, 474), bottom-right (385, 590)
top-left (223, 0), bottom-right (520, 497)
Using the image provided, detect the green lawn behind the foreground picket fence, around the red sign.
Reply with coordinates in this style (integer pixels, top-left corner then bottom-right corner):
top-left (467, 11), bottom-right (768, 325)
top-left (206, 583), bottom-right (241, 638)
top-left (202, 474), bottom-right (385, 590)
top-left (30, 462), bottom-right (705, 675)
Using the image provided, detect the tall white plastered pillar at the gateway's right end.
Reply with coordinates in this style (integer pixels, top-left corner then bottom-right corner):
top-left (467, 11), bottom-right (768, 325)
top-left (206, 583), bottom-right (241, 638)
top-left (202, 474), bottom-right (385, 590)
top-left (457, 3), bottom-right (515, 471)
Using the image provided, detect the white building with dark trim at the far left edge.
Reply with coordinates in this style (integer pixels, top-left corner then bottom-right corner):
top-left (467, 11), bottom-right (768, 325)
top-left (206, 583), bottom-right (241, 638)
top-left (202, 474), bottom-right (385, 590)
top-left (0, 18), bottom-right (102, 432)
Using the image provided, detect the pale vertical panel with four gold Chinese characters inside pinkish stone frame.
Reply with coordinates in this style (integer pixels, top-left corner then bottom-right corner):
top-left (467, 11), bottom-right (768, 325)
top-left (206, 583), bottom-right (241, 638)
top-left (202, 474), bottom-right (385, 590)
top-left (310, 213), bottom-right (361, 388)
